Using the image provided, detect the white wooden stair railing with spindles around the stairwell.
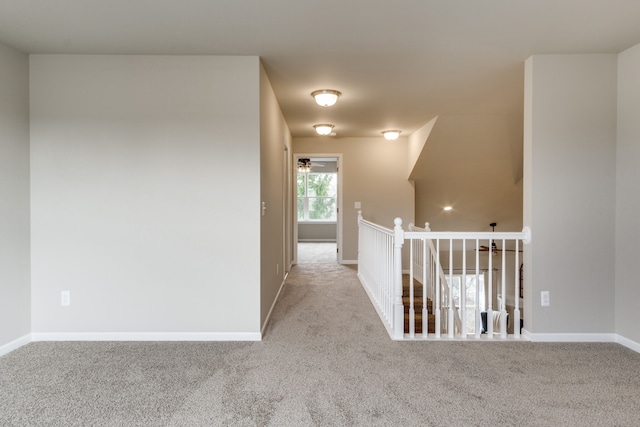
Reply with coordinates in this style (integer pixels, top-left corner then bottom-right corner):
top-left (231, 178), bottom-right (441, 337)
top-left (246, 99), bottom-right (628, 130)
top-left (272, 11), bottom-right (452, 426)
top-left (358, 212), bottom-right (531, 339)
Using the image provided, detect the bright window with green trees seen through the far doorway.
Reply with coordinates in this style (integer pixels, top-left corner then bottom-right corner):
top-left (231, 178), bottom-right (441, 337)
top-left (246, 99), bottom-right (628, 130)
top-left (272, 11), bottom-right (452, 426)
top-left (298, 172), bottom-right (338, 222)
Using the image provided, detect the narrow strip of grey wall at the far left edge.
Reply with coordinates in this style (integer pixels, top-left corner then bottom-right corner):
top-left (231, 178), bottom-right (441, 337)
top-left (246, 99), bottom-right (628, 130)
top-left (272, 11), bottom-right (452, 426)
top-left (0, 43), bottom-right (31, 355)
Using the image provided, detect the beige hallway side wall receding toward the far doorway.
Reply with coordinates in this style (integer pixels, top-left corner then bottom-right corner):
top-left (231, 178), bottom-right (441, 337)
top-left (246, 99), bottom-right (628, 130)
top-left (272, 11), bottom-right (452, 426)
top-left (260, 64), bottom-right (291, 329)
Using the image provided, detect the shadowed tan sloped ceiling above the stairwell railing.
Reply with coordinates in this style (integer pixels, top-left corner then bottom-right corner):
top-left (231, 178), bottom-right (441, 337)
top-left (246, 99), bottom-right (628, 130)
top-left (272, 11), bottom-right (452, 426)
top-left (410, 115), bottom-right (523, 231)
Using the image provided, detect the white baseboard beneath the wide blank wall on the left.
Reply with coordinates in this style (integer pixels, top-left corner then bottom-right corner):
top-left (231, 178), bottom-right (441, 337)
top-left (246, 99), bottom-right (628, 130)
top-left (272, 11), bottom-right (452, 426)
top-left (31, 332), bottom-right (262, 341)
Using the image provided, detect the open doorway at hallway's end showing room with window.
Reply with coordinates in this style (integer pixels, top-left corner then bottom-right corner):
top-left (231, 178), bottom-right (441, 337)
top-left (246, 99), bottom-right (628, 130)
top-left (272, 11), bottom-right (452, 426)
top-left (293, 154), bottom-right (342, 264)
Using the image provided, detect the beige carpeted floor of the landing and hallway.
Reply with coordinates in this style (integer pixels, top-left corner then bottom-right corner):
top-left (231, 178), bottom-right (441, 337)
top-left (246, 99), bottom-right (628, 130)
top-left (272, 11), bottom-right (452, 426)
top-left (0, 263), bottom-right (640, 426)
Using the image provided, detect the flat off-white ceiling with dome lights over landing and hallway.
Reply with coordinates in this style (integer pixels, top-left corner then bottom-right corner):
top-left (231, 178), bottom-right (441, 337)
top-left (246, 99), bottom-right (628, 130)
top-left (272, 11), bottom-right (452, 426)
top-left (0, 0), bottom-right (640, 136)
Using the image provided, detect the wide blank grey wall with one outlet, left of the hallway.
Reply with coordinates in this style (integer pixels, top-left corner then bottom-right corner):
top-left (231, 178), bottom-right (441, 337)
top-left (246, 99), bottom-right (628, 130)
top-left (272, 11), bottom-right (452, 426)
top-left (30, 55), bottom-right (262, 339)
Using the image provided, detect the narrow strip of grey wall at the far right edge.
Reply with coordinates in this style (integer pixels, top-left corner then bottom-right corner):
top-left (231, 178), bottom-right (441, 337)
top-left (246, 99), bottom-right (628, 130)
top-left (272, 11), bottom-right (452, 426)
top-left (615, 45), bottom-right (640, 346)
